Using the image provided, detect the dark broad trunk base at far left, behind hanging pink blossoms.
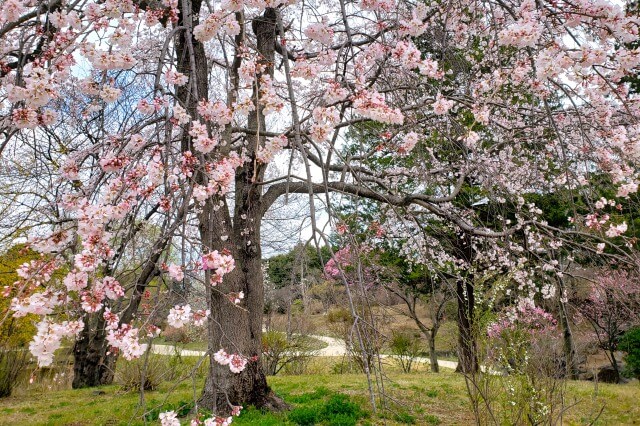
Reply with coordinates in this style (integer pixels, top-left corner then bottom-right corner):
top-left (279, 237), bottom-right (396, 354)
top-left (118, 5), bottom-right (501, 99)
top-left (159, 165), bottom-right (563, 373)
top-left (72, 311), bottom-right (116, 389)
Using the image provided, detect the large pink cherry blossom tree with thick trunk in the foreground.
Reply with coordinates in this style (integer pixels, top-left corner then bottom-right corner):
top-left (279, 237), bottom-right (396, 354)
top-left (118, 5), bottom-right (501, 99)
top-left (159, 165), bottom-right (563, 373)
top-left (0, 0), bottom-right (640, 421)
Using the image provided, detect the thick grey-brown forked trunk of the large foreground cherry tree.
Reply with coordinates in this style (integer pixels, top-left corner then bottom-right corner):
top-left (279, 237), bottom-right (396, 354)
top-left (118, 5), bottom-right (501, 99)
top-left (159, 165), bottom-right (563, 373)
top-left (194, 5), bottom-right (286, 415)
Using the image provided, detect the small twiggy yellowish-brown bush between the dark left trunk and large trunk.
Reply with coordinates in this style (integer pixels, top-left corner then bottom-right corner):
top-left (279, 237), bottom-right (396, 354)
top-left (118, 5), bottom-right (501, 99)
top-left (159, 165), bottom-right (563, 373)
top-left (116, 354), bottom-right (173, 391)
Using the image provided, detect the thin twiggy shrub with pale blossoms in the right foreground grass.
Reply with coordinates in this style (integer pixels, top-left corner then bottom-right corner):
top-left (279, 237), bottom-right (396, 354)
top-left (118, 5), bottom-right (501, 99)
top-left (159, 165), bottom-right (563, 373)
top-left (473, 299), bottom-right (564, 425)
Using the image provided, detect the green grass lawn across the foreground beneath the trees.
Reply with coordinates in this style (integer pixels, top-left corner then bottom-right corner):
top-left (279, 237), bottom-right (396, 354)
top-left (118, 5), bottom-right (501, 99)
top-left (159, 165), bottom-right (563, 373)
top-left (0, 368), bottom-right (640, 426)
